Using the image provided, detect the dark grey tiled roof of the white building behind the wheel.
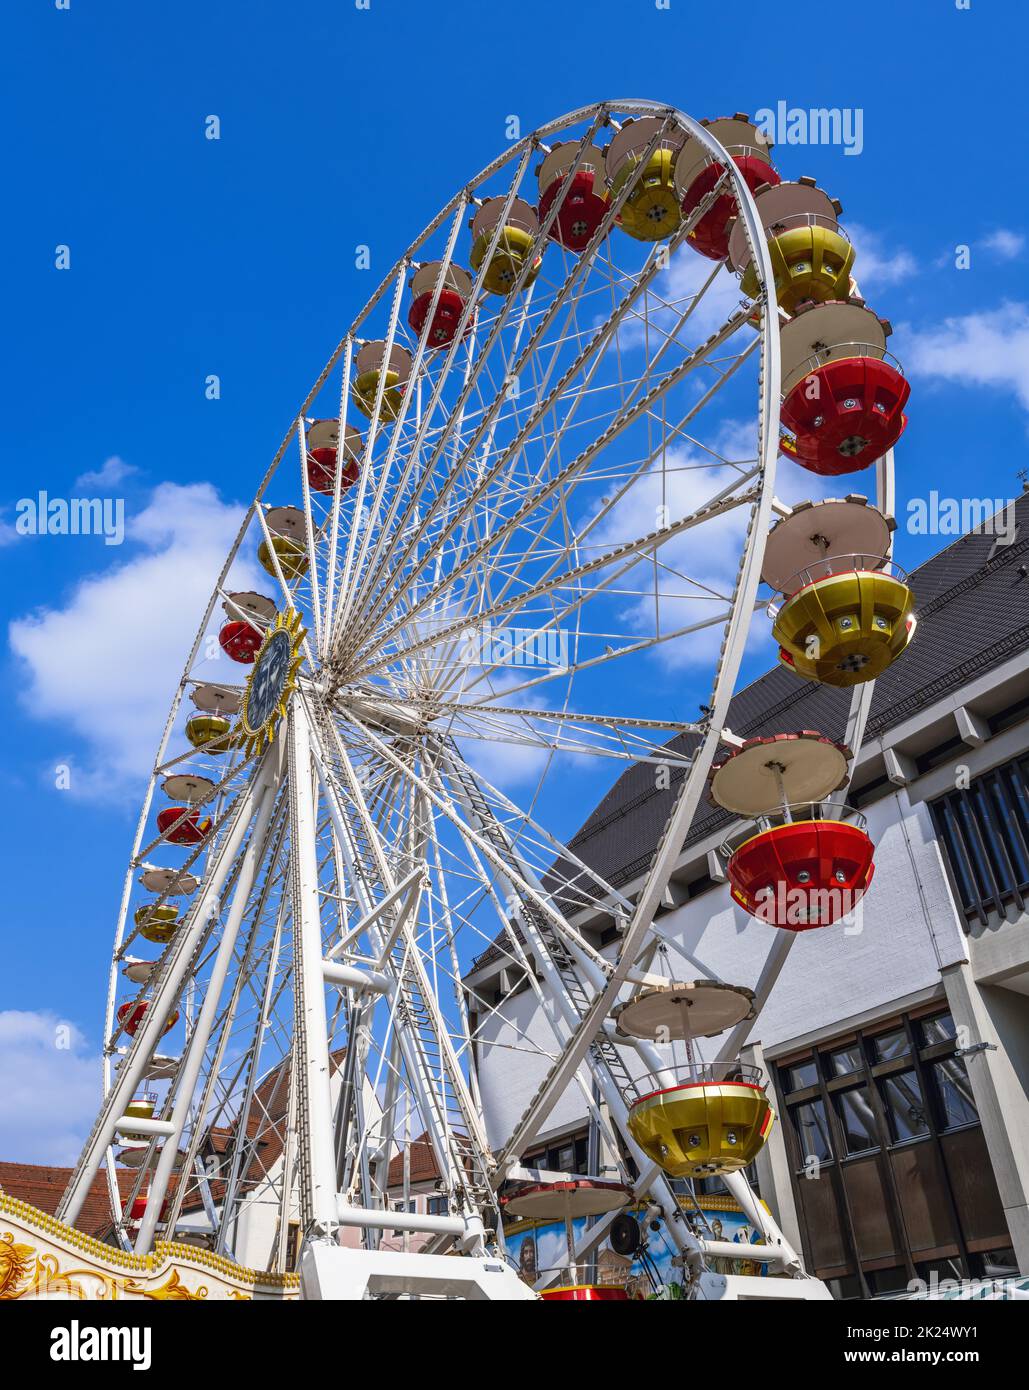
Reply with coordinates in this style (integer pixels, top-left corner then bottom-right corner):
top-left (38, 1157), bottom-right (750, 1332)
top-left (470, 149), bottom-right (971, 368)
top-left (473, 493), bottom-right (1029, 969)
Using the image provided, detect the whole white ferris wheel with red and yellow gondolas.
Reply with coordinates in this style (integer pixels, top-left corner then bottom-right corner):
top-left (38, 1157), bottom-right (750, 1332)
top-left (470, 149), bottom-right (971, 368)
top-left (60, 101), bottom-right (914, 1297)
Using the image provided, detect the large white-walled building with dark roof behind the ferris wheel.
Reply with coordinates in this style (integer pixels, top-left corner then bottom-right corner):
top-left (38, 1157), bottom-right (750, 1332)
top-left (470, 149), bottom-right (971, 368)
top-left (466, 496), bottom-right (1029, 1297)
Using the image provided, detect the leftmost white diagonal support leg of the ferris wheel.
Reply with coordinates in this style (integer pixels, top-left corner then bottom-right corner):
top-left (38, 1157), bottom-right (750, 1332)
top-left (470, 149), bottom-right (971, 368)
top-left (57, 753), bottom-right (274, 1226)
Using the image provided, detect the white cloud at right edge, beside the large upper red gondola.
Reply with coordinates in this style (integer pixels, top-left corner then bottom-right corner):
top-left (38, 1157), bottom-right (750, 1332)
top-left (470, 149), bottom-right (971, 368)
top-left (898, 303), bottom-right (1029, 410)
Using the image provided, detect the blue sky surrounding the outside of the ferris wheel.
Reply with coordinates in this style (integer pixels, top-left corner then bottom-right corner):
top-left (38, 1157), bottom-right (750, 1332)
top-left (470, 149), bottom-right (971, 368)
top-left (0, 0), bottom-right (1029, 1161)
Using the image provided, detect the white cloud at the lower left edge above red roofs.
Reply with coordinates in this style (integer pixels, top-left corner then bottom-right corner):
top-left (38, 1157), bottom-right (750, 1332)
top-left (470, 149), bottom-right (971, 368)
top-left (0, 1009), bottom-right (100, 1165)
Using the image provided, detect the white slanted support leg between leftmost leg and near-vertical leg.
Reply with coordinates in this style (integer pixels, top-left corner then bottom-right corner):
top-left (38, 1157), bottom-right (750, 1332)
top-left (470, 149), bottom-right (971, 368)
top-left (135, 748), bottom-right (281, 1255)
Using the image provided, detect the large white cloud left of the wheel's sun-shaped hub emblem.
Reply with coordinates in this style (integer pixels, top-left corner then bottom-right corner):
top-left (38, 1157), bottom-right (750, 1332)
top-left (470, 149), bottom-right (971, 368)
top-left (10, 482), bottom-right (256, 798)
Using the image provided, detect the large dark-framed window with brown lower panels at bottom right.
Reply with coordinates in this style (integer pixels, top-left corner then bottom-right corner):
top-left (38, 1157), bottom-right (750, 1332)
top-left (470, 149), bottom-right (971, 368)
top-left (775, 1005), bottom-right (1014, 1298)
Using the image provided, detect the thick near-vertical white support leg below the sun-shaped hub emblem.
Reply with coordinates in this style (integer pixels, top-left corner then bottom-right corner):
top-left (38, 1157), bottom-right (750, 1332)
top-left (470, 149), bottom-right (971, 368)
top-left (289, 698), bottom-right (343, 1234)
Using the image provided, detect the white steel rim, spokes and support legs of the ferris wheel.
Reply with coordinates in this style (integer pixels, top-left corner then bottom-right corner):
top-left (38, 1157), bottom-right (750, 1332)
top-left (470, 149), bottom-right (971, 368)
top-left (60, 100), bottom-right (893, 1301)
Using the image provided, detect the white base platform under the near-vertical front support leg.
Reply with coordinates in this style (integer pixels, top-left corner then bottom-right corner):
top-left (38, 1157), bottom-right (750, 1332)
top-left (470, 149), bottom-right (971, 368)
top-left (299, 1241), bottom-right (538, 1302)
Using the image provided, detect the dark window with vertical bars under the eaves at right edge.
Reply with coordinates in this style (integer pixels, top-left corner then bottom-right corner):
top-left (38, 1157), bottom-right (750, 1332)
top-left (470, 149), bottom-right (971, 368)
top-left (930, 755), bottom-right (1029, 926)
